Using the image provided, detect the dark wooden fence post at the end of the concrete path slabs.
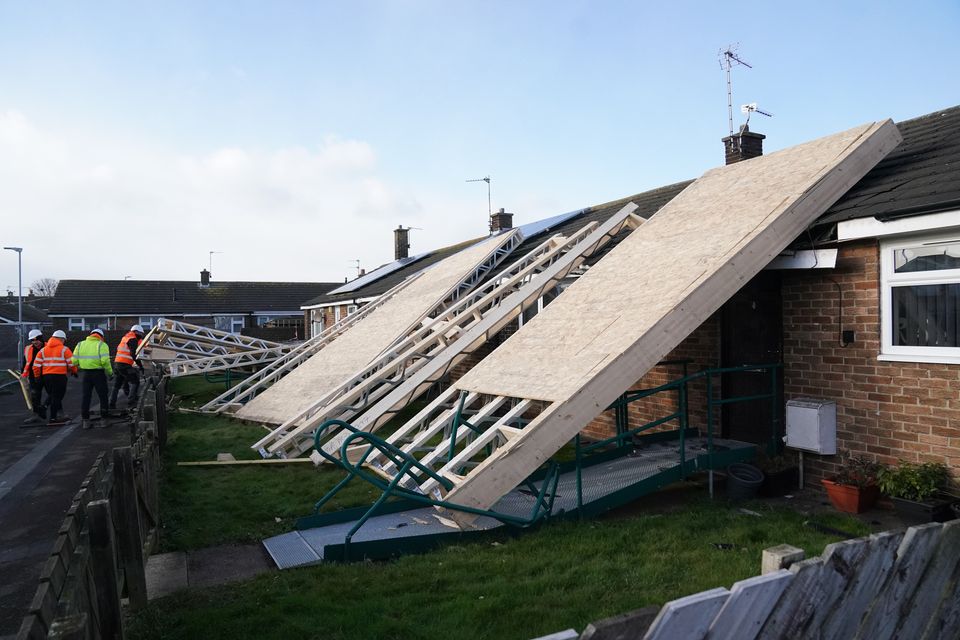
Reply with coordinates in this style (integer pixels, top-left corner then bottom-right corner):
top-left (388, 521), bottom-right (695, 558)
top-left (113, 447), bottom-right (147, 611)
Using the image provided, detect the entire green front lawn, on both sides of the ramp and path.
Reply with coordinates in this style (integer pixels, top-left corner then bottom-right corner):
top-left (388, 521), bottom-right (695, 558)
top-left (142, 378), bottom-right (869, 640)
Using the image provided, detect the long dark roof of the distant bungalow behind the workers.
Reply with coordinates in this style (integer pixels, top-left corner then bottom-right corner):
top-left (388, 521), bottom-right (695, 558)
top-left (50, 280), bottom-right (340, 315)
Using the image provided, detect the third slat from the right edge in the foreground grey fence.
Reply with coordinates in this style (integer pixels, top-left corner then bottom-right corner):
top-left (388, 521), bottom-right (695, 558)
top-left (820, 531), bottom-right (904, 639)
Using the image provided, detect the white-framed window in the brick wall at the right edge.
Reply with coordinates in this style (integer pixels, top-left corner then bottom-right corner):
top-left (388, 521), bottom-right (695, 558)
top-left (879, 232), bottom-right (960, 364)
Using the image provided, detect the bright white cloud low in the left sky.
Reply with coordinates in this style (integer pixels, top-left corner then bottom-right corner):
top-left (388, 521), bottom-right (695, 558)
top-left (0, 111), bottom-right (438, 281)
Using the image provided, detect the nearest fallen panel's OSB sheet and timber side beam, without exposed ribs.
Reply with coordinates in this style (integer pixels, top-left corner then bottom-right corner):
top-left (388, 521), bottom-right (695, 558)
top-left (448, 120), bottom-right (900, 509)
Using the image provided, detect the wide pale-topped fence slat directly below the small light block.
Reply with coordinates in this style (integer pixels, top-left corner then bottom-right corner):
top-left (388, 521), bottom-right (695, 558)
top-left (707, 569), bottom-right (794, 640)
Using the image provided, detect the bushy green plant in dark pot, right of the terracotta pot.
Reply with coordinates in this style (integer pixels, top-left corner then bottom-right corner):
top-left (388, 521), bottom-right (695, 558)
top-left (879, 460), bottom-right (956, 524)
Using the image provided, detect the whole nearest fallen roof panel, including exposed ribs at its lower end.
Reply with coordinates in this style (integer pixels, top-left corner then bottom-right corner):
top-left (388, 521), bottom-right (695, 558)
top-left (316, 120), bottom-right (900, 526)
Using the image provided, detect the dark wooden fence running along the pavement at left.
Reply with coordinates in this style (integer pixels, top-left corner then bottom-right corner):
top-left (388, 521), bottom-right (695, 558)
top-left (17, 380), bottom-right (167, 640)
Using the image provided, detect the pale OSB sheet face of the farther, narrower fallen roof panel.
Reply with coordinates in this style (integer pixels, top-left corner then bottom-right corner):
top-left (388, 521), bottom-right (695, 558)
top-left (237, 232), bottom-right (516, 424)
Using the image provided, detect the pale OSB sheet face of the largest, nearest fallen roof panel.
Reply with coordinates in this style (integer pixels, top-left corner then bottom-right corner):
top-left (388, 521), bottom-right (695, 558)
top-left (457, 125), bottom-right (895, 400)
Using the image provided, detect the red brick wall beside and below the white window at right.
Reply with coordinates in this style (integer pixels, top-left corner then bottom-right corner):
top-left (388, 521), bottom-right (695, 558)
top-left (783, 241), bottom-right (960, 481)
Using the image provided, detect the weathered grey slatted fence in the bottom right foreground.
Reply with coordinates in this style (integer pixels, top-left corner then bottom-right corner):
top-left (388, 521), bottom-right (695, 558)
top-left (541, 520), bottom-right (960, 640)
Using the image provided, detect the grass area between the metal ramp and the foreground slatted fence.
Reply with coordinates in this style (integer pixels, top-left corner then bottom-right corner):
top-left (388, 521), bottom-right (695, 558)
top-left (130, 498), bottom-right (867, 640)
